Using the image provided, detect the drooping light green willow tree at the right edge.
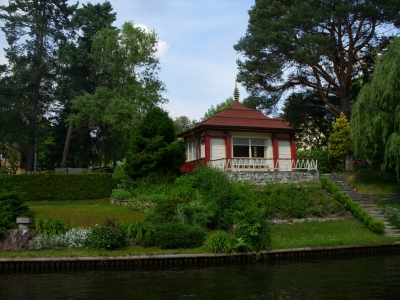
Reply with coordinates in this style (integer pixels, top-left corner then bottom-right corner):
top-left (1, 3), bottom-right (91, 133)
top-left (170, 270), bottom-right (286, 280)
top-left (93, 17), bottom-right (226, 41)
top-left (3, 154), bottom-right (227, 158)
top-left (351, 38), bottom-right (400, 179)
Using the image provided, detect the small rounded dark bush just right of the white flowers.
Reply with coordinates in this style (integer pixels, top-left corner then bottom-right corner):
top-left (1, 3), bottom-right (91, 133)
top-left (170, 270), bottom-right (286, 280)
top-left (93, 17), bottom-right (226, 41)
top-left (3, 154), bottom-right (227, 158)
top-left (88, 224), bottom-right (126, 250)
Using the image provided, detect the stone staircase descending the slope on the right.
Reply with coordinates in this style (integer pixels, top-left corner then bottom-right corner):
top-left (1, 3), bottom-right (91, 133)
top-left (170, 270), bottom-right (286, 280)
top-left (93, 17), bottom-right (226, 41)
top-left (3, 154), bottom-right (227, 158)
top-left (327, 174), bottom-right (400, 237)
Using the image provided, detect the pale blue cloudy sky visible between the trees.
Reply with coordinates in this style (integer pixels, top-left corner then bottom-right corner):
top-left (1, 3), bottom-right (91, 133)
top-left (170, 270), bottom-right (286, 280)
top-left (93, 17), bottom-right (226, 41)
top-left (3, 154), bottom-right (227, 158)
top-left (0, 0), bottom-right (254, 120)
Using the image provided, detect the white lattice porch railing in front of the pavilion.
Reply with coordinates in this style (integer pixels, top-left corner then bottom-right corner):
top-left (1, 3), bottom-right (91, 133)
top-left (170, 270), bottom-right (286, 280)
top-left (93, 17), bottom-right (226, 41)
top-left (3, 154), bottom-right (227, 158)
top-left (208, 158), bottom-right (318, 172)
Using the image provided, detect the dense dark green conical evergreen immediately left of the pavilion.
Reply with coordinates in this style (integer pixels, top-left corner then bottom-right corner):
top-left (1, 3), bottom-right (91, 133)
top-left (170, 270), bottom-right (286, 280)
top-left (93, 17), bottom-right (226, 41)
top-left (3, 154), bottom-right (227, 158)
top-left (125, 107), bottom-right (186, 180)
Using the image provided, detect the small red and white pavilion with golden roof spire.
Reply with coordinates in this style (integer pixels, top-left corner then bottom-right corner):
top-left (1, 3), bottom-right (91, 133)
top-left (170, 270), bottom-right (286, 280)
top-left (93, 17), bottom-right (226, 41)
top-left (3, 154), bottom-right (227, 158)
top-left (178, 87), bottom-right (317, 173)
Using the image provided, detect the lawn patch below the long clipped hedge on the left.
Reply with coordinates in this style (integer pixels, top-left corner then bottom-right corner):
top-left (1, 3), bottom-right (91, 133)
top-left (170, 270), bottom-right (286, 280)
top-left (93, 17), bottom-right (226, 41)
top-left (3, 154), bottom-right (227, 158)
top-left (26, 199), bottom-right (145, 228)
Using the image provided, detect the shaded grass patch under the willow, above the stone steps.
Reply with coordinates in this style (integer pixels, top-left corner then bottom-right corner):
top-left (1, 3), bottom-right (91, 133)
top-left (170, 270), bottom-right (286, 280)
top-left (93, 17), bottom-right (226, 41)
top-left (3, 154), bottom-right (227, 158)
top-left (347, 170), bottom-right (400, 194)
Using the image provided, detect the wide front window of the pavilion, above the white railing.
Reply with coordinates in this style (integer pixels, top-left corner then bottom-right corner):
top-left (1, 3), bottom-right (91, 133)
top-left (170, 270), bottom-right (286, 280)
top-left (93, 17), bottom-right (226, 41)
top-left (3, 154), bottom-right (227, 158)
top-left (233, 138), bottom-right (267, 158)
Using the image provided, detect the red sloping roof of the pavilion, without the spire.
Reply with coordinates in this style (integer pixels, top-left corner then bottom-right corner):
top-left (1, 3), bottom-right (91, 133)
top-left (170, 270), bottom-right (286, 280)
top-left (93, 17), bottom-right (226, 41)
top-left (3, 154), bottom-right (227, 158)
top-left (194, 102), bottom-right (293, 130)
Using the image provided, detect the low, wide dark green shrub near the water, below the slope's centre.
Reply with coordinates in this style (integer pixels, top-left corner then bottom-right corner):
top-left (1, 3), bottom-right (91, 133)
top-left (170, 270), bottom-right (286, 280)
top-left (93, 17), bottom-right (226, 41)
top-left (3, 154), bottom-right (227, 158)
top-left (144, 223), bottom-right (206, 249)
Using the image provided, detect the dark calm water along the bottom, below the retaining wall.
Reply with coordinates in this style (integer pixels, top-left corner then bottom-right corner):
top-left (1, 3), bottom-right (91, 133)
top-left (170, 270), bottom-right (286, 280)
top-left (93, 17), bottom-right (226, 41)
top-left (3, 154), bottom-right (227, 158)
top-left (0, 256), bottom-right (400, 300)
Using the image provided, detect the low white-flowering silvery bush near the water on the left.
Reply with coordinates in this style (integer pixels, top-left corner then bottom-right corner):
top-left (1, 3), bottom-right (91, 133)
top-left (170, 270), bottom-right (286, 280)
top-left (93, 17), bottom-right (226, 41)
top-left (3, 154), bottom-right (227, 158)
top-left (32, 228), bottom-right (91, 250)
